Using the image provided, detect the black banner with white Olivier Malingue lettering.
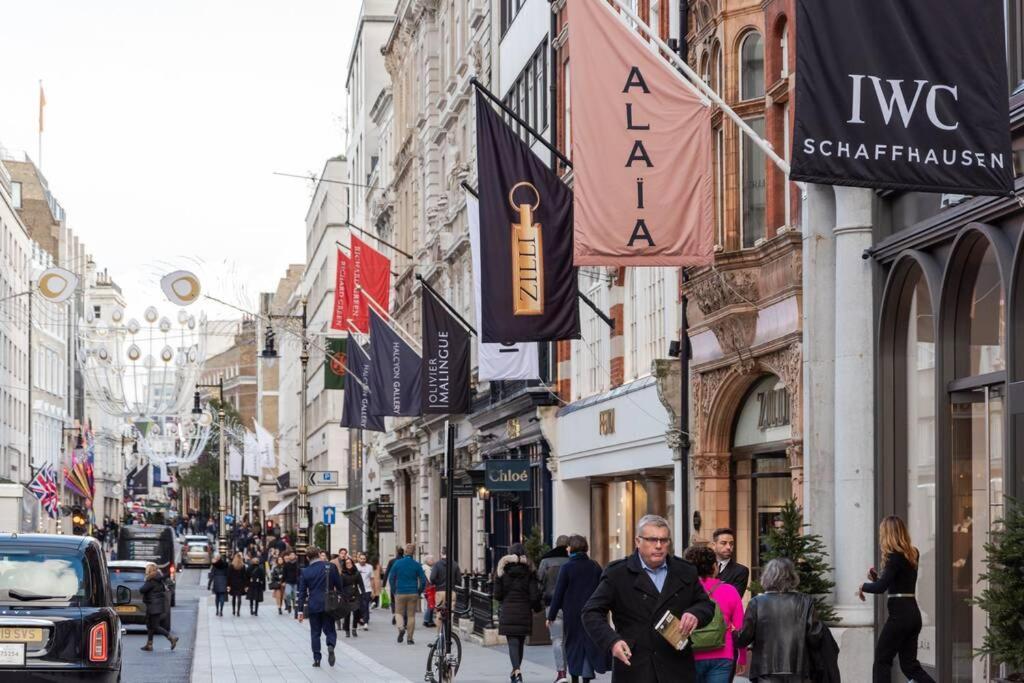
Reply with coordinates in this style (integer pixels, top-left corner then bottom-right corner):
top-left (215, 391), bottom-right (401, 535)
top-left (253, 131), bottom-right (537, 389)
top-left (421, 288), bottom-right (470, 415)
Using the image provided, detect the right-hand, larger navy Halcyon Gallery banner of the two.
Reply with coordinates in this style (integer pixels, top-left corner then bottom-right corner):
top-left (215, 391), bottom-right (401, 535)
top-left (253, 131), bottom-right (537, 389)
top-left (370, 309), bottom-right (422, 417)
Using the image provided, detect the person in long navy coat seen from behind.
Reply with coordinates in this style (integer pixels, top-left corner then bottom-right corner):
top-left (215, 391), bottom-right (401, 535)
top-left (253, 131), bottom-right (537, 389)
top-left (542, 535), bottom-right (611, 683)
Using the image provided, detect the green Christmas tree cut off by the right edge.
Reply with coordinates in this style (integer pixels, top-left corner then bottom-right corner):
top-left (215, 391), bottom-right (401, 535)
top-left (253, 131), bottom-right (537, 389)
top-left (974, 499), bottom-right (1024, 681)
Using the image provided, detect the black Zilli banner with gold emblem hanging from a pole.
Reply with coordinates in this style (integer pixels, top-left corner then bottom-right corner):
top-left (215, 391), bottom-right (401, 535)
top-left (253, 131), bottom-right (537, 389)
top-left (476, 92), bottom-right (580, 343)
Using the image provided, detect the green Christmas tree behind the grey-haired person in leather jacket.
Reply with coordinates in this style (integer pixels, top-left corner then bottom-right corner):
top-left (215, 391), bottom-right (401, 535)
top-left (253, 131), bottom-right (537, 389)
top-left (751, 499), bottom-right (840, 624)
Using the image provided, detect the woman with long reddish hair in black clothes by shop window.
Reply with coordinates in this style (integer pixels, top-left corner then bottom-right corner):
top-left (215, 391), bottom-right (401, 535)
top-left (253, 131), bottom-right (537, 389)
top-left (857, 515), bottom-right (934, 683)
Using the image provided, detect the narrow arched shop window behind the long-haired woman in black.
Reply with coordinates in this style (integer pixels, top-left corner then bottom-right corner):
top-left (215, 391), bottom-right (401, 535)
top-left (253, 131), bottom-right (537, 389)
top-left (905, 270), bottom-right (936, 667)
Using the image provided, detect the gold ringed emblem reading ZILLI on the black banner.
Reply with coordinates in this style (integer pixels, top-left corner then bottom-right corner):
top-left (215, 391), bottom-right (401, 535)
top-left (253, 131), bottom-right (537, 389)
top-left (509, 181), bottom-right (544, 315)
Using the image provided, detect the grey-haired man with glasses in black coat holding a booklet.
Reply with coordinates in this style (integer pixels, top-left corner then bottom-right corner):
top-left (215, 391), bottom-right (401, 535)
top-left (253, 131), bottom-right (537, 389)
top-left (583, 515), bottom-right (715, 683)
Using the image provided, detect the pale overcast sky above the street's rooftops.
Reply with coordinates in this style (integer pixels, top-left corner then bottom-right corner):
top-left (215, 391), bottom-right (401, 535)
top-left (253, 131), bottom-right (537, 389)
top-left (0, 0), bottom-right (360, 317)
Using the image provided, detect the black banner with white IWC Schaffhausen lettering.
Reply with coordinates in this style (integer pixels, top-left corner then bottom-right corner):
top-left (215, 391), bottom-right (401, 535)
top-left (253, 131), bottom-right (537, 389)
top-left (792, 0), bottom-right (1014, 195)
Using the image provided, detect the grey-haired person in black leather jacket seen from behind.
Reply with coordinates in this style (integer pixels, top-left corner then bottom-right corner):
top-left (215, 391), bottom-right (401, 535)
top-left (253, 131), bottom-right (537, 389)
top-left (733, 558), bottom-right (825, 683)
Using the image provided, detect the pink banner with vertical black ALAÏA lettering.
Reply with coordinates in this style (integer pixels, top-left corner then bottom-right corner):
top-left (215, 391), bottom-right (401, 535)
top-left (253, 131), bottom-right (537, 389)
top-left (568, 0), bottom-right (714, 266)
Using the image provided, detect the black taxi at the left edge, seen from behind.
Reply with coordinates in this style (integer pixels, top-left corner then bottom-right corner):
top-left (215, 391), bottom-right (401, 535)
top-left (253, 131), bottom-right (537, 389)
top-left (0, 533), bottom-right (131, 682)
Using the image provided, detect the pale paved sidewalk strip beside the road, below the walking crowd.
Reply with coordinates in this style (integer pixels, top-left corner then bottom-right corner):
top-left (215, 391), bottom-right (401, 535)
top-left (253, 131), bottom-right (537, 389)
top-left (191, 596), bottom-right (411, 683)
